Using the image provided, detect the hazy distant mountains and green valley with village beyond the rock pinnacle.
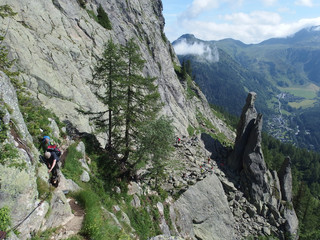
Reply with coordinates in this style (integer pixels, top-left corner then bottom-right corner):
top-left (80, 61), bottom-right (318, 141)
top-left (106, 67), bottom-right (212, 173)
top-left (172, 26), bottom-right (320, 151)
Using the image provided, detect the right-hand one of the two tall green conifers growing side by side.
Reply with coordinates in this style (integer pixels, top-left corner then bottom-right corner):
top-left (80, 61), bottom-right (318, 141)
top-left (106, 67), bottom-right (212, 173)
top-left (121, 39), bottom-right (160, 167)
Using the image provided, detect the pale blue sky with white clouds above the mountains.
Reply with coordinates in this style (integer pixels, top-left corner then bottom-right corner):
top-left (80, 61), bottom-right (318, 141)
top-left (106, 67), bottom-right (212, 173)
top-left (162, 0), bottom-right (320, 44)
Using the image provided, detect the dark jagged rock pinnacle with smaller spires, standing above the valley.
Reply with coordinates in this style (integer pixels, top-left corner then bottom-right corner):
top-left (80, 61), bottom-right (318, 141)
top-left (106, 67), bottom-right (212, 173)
top-left (228, 93), bottom-right (298, 239)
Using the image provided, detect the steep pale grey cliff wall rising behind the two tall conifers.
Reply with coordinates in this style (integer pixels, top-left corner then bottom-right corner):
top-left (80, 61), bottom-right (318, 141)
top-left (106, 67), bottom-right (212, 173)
top-left (0, 0), bottom-right (233, 144)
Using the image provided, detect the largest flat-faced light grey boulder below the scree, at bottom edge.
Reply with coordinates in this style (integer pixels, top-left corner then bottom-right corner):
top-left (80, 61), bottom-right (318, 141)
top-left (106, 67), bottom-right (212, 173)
top-left (171, 175), bottom-right (235, 240)
